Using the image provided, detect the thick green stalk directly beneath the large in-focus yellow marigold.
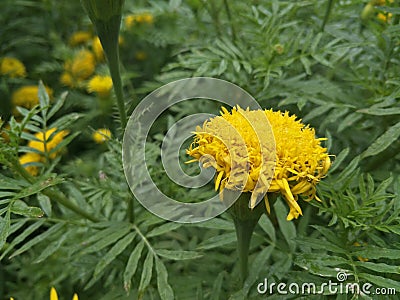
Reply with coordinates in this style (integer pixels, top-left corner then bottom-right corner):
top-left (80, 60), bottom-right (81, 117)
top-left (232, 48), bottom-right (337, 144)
top-left (228, 193), bottom-right (266, 285)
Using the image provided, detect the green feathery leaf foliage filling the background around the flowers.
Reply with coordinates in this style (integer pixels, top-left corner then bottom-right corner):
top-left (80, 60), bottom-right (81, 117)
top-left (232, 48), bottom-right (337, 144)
top-left (0, 0), bottom-right (400, 300)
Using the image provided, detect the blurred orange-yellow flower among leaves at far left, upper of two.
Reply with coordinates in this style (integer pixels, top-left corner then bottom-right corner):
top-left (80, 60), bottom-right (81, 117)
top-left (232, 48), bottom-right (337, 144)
top-left (28, 128), bottom-right (69, 158)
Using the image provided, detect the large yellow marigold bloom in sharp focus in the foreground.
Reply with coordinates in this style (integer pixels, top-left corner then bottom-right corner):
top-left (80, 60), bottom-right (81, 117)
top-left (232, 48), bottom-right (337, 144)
top-left (187, 107), bottom-right (330, 220)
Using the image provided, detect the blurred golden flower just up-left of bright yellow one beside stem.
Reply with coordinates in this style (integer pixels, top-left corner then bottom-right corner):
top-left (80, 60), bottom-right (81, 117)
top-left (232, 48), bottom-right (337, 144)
top-left (64, 49), bottom-right (96, 81)
